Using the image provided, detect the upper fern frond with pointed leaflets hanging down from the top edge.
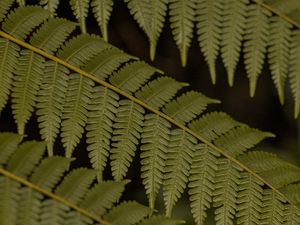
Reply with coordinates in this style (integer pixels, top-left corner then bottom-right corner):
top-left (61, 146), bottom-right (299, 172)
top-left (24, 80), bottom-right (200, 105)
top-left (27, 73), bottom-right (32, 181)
top-left (37, 0), bottom-right (300, 117)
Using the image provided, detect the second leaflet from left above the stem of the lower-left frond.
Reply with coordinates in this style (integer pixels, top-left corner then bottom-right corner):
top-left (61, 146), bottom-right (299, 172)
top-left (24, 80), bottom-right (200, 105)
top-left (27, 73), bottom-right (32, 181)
top-left (7, 141), bottom-right (45, 177)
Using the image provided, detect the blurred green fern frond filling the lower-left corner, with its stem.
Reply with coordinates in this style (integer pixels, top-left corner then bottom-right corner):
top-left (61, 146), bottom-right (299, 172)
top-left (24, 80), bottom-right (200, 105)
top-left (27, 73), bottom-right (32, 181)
top-left (0, 133), bottom-right (180, 225)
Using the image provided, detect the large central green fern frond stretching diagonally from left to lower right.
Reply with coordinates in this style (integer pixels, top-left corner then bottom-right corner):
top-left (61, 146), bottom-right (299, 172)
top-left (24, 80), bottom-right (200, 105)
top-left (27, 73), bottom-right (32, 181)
top-left (0, 3), bottom-right (300, 225)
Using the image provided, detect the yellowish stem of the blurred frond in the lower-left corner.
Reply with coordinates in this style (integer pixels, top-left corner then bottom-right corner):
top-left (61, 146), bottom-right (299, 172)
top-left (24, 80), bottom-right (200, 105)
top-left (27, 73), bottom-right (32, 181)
top-left (0, 168), bottom-right (112, 225)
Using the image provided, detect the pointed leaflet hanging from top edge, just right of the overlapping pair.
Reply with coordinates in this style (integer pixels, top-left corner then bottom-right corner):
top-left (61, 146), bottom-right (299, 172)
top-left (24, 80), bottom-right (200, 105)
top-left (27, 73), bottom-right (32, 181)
top-left (169, 0), bottom-right (196, 66)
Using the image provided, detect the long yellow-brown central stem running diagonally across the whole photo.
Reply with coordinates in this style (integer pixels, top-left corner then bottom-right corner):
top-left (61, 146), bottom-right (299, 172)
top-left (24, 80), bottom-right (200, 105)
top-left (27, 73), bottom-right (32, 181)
top-left (0, 30), bottom-right (294, 205)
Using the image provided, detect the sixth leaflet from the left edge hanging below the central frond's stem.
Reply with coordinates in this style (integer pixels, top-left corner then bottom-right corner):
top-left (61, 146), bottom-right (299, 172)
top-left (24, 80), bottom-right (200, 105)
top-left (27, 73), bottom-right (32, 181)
top-left (111, 100), bottom-right (145, 180)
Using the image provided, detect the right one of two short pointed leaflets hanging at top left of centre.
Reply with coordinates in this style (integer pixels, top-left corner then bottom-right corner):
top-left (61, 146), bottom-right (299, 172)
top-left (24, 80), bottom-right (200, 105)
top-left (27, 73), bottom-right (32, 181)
top-left (91, 0), bottom-right (114, 41)
